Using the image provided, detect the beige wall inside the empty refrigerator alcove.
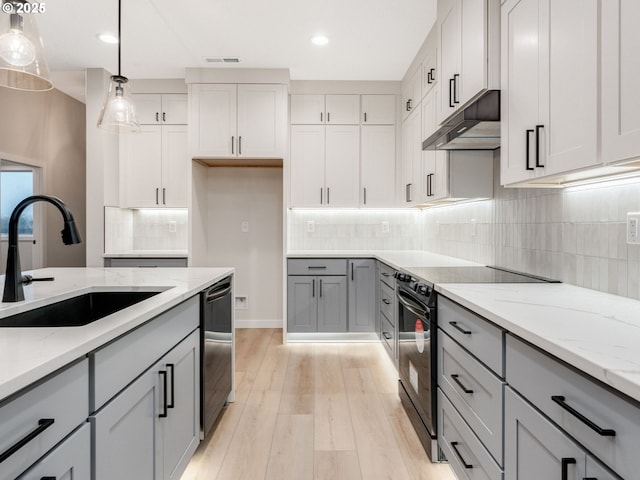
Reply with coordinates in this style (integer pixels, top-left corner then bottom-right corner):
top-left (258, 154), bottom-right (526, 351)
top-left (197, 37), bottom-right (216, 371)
top-left (205, 167), bottom-right (283, 328)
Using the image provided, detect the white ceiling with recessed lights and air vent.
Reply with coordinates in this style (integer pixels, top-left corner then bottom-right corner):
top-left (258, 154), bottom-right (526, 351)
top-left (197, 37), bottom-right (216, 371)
top-left (37, 0), bottom-right (436, 100)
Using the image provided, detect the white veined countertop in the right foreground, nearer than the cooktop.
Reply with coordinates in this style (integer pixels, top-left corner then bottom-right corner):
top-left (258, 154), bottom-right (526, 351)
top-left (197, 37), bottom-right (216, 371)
top-left (436, 283), bottom-right (640, 401)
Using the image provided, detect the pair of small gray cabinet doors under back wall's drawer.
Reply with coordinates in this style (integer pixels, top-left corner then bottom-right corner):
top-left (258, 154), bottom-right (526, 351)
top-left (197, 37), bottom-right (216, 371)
top-left (287, 275), bottom-right (347, 333)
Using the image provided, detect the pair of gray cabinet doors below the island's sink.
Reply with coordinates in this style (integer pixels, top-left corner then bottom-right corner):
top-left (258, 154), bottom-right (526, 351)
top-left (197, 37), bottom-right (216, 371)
top-left (90, 331), bottom-right (200, 480)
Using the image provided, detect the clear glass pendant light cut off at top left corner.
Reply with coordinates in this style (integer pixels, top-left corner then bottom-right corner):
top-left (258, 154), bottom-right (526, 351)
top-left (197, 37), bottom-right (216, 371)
top-left (0, 0), bottom-right (53, 91)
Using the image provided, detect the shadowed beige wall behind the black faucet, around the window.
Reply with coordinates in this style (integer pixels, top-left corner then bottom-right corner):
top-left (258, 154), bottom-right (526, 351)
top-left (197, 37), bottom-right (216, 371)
top-left (0, 88), bottom-right (87, 267)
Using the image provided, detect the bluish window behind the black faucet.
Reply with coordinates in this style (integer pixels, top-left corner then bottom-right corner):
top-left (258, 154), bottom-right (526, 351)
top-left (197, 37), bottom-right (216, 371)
top-left (0, 170), bottom-right (33, 235)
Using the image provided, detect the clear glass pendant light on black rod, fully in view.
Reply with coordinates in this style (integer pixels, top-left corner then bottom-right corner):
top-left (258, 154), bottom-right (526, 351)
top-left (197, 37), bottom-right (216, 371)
top-left (98, 0), bottom-right (140, 133)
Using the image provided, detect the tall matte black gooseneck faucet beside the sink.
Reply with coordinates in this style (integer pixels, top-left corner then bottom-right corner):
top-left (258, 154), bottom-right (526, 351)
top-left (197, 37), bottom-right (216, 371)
top-left (2, 195), bottom-right (82, 302)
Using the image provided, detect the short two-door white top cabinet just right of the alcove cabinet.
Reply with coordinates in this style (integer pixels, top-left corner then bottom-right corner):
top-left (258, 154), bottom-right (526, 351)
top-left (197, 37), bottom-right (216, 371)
top-left (291, 94), bottom-right (360, 125)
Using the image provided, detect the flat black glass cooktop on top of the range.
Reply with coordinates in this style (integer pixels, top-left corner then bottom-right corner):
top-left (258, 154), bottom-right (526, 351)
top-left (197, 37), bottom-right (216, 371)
top-left (404, 266), bottom-right (560, 284)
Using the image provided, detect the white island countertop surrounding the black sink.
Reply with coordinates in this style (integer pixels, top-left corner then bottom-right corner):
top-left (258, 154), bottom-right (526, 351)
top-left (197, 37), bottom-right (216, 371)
top-left (0, 268), bottom-right (234, 400)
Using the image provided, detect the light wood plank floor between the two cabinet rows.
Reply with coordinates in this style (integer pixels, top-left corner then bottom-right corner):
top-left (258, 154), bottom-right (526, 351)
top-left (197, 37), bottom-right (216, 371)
top-left (182, 329), bottom-right (455, 480)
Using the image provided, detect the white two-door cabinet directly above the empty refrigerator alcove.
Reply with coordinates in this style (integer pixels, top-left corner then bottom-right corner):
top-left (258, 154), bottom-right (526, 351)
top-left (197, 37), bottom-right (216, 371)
top-left (189, 84), bottom-right (287, 158)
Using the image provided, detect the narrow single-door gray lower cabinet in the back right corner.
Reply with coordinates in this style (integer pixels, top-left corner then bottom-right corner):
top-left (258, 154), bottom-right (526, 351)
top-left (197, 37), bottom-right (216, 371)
top-left (348, 258), bottom-right (376, 332)
